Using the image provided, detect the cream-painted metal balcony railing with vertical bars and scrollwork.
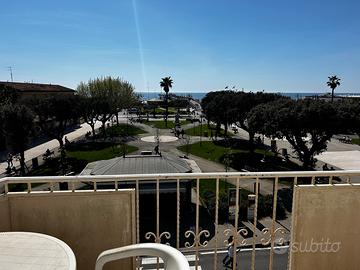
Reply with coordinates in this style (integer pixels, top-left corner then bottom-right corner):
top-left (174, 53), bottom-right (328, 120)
top-left (0, 170), bottom-right (360, 269)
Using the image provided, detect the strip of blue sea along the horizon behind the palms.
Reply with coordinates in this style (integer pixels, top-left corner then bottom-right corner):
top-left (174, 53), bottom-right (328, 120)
top-left (137, 92), bottom-right (360, 101)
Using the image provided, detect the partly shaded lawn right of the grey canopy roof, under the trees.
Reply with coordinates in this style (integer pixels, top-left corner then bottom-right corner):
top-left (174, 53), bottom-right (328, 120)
top-left (178, 139), bottom-right (302, 171)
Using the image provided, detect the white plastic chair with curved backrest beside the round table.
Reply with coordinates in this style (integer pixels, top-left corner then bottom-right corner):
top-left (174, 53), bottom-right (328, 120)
top-left (95, 243), bottom-right (190, 270)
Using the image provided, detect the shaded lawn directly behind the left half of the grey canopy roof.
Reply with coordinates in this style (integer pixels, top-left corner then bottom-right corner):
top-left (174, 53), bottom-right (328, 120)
top-left (66, 142), bottom-right (138, 162)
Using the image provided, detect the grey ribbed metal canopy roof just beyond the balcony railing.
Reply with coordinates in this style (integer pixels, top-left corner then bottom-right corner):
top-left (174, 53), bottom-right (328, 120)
top-left (81, 155), bottom-right (191, 175)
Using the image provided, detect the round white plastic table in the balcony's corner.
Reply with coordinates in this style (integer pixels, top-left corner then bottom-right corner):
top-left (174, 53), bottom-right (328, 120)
top-left (0, 232), bottom-right (76, 270)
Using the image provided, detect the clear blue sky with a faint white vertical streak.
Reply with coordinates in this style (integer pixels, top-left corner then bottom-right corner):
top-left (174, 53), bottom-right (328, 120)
top-left (0, 0), bottom-right (360, 93)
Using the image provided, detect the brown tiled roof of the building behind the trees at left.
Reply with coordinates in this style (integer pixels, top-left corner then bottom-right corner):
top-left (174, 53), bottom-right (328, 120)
top-left (0, 81), bottom-right (75, 93)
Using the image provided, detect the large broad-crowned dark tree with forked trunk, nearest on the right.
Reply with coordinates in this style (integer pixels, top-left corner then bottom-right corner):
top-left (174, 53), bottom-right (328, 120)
top-left (248, 99), bottom-right (342, 168)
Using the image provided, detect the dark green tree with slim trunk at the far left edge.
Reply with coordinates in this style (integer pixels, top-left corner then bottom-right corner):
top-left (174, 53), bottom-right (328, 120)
top-left (0, 104), bottom-right (34, 175)
